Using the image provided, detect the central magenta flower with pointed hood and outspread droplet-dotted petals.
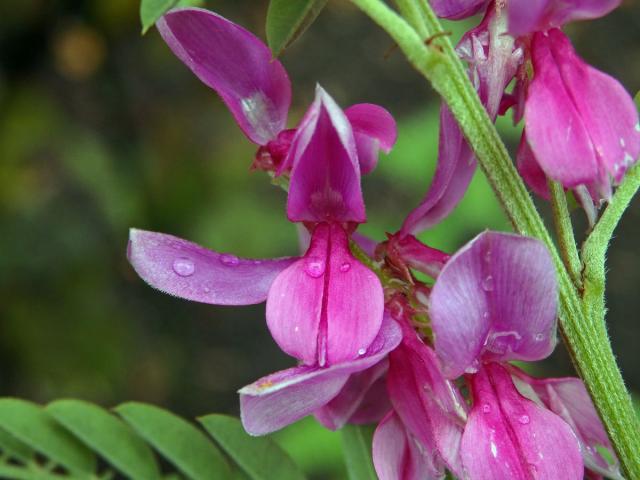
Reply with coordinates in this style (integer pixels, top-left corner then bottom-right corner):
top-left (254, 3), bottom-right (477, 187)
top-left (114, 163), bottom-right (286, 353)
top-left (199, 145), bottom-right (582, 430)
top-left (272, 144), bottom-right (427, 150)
top-left (128, 8), bottom-right (400, 435)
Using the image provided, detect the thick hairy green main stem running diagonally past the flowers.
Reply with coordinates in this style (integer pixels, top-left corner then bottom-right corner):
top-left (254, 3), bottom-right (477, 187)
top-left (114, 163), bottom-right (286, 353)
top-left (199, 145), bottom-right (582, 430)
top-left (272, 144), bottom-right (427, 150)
top-left (351, 0), bottom-right (640, 478)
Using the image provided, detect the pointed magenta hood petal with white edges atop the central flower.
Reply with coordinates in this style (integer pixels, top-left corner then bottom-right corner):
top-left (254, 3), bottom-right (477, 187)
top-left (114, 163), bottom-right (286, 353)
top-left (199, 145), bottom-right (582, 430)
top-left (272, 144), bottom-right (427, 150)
top-left (283, 86), bottom-right (366, 223)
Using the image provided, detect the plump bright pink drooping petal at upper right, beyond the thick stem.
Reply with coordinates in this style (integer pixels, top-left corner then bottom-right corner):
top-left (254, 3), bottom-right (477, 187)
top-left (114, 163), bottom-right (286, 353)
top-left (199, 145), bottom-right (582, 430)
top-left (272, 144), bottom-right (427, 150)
top-left (519, 29), bottom-right (640, 200)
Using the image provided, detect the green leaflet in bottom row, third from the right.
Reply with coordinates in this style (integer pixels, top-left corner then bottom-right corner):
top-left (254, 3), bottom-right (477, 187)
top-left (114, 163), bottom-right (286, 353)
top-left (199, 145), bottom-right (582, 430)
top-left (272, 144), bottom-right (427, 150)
top-left (46, 400), bottom-right (161, 480)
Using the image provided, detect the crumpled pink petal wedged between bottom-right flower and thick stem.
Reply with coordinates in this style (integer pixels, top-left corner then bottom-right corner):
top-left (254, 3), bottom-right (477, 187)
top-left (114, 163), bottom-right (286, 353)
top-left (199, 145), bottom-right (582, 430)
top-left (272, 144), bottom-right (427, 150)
top-left (510, 366), bottom-right (622, 480)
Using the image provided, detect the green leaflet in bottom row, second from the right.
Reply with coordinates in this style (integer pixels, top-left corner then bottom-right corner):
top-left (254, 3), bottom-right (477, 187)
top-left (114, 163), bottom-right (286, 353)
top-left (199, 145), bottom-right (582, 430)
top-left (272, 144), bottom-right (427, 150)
top-left (114, 402), bottom-right (231, 480)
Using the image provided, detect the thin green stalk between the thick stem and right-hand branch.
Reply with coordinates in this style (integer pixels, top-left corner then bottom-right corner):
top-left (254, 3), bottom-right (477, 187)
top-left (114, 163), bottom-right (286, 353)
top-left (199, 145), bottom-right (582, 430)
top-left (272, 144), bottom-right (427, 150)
top-left (548, 180), bottom-right (582, 291)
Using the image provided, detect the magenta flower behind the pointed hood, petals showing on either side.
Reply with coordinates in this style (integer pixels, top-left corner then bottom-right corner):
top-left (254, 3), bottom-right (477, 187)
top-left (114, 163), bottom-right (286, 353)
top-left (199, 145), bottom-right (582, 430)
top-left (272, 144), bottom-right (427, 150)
top-left (157, 8), bottom-right (397, 173)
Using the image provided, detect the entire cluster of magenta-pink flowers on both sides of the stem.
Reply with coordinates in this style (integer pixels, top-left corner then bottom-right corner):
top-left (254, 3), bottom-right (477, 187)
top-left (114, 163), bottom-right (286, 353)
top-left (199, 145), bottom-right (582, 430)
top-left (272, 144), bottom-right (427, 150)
top-left (128, 4), bottom-right (624, 480)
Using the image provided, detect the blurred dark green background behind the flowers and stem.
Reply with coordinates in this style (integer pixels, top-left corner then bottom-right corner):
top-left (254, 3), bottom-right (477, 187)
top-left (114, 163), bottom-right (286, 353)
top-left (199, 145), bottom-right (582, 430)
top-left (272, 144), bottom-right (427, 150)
top-left (0, 0), bottom-right (640, 478)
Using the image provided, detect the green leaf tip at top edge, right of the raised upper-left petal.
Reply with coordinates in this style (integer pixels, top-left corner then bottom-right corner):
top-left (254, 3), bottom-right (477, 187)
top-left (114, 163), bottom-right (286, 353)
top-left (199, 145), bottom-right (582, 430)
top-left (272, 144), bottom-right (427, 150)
top-left (266, 0), bottom-right (327, 57)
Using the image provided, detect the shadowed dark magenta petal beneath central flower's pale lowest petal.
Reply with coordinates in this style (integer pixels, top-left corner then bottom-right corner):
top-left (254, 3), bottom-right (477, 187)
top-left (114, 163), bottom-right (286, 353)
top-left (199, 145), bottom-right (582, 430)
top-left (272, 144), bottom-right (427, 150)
top-left (314, 360), bottom-right (391, 430)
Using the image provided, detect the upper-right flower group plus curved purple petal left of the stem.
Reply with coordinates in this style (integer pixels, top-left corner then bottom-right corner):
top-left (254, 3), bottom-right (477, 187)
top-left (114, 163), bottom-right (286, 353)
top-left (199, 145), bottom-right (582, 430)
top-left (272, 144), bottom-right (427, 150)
top-left (412, 0), bottom-right (640, 232)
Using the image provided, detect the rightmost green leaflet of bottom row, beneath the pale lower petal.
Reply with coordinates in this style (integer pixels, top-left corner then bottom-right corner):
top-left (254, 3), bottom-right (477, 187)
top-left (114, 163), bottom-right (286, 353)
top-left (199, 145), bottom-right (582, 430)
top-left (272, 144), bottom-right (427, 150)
top-left (198, 415), bottom-right (304, 480)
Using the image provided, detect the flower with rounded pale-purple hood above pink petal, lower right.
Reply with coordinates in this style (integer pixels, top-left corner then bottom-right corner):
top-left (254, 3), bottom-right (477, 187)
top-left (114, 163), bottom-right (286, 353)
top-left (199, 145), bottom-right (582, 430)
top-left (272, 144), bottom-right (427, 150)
top-left (430, 232), bottom-right (584, 479)
